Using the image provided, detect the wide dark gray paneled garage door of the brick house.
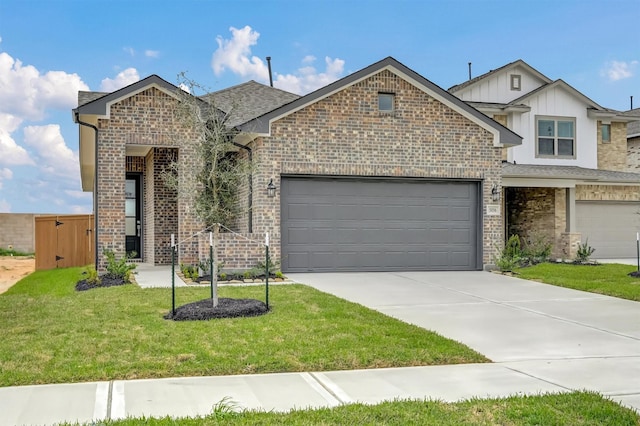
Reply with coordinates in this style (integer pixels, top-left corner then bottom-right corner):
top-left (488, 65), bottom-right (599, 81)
top-left (281, 177), bottom-right (482, 272)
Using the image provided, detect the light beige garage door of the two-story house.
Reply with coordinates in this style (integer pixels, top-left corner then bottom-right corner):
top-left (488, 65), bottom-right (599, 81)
top-left (576, 201), bottom-right (640, 259)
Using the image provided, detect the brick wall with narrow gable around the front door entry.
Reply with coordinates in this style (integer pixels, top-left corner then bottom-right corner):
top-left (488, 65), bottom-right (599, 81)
top-left (97, 88), bottom-right (202, 270)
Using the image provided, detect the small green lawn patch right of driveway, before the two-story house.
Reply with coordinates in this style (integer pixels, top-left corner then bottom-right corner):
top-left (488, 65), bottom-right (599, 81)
top-left (516, 263), bottom-right (640, 301)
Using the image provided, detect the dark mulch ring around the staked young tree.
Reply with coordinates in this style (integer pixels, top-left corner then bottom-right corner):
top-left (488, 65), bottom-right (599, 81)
top-left (164, 297), bottom-right (269, 321)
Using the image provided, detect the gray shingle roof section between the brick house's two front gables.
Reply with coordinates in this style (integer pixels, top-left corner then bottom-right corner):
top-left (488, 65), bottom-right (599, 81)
top-left (201, 80), bottom-right (300, 127)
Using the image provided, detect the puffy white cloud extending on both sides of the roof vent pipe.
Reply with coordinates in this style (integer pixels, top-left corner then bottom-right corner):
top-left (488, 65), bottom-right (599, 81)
top-left (211, 25), bottom-right (344, 94)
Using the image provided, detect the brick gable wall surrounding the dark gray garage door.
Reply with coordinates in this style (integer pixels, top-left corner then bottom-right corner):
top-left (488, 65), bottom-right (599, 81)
top-left (254, 70), bottom-right (504, 264)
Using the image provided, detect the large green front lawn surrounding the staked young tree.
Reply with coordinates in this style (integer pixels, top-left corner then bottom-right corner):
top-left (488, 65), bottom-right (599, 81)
top-left (0, 268), bottom-right (488, 386)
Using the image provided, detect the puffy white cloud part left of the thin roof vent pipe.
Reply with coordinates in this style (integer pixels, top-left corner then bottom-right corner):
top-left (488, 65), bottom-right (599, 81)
top-left (211, 25), bottom-right (269, 81)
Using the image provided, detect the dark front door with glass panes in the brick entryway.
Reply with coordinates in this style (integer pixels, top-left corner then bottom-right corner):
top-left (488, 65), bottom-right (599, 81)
top-left (124, 173), bottom-right (142, 259)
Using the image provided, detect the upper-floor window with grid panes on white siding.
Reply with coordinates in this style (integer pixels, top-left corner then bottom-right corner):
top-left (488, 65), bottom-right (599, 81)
top-left (537, 117), bottom-right (576, 157)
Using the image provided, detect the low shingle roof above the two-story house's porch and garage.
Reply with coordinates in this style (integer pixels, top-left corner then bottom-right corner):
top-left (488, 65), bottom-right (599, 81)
top-left (502, 163), bottom-right (640, 183)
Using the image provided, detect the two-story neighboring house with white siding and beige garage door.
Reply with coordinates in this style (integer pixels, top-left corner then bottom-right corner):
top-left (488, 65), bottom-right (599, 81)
top-left (449, 60), bottom-right (640, 258)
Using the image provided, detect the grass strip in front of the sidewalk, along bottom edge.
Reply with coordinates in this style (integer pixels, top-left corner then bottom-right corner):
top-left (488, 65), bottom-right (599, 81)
top-left (67, 392), bottom-right (640, 426)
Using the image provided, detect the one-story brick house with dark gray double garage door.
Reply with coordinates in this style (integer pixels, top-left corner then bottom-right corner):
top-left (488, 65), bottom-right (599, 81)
top-left (74, 58), bottom-right (521, 272)
